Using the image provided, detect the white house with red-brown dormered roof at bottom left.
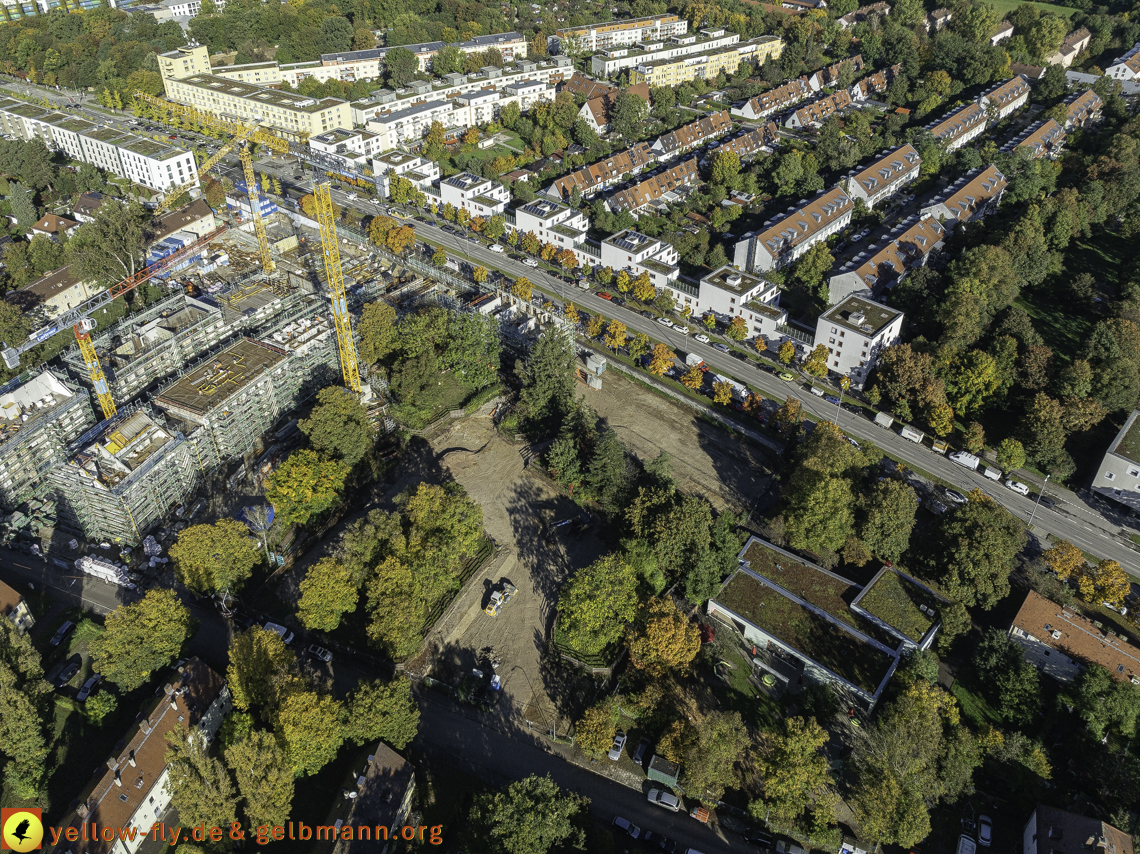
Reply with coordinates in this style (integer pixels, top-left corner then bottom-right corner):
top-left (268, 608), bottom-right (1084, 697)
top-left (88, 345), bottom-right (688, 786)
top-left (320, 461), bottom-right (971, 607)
top-left (57, 658), bottom-right (233, 854)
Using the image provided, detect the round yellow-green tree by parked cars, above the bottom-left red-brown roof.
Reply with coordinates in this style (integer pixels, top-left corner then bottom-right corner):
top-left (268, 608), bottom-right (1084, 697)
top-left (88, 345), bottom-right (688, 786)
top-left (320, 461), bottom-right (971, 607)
top-left (91, 589), bottom-right (190, 691)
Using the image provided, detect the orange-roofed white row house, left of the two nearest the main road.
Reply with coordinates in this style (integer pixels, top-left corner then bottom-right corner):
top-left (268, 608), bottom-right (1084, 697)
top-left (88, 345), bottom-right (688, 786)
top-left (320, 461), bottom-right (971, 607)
top-left (733, 187), bottom-right (854, 273)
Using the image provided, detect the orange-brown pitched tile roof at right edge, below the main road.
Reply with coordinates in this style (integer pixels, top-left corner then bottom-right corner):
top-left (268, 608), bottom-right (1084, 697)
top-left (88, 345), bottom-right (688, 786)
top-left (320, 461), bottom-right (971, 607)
top-left (1011, 591), bottom-right (1140, 682)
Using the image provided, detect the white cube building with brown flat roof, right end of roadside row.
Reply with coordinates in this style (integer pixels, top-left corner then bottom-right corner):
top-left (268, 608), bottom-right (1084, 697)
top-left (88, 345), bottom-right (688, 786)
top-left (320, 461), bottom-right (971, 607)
top-left (815, 296), bottom-right (903, 387)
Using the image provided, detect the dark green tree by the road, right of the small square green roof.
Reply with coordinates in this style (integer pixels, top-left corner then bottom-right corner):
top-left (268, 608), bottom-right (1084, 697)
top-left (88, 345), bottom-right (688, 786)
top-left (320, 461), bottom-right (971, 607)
top-left (931, 489), bottom-right (1028, 610)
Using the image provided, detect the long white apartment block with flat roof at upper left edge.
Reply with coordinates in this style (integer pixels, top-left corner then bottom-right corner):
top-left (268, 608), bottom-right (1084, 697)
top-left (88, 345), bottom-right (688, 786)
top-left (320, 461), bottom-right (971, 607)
top-left (0, 98), bottom-right (198, 192)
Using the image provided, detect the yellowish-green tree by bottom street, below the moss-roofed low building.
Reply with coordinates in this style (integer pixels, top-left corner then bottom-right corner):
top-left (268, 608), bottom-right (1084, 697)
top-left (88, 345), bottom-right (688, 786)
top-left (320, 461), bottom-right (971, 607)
top-left (748, 717), bottom-right (833, 827)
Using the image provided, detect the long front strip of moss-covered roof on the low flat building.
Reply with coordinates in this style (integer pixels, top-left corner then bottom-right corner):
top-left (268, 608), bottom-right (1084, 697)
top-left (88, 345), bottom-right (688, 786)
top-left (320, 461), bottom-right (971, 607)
top-left (717, 572), bottom-right (893, 693)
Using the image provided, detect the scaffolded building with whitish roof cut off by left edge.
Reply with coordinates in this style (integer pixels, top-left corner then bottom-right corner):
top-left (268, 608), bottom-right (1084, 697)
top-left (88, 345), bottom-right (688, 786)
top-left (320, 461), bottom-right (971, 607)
top-left (0, 371), bottom-right (95, 510)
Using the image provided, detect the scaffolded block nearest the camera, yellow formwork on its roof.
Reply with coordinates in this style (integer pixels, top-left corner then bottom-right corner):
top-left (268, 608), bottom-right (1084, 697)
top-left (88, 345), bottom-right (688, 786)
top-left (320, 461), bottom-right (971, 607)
top-left (49, 407), bottom-right (217, 545)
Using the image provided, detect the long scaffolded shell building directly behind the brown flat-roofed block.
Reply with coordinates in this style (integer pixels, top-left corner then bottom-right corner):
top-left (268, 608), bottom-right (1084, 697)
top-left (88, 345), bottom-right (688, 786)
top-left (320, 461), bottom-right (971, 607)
top-left (64, 277), bottom-right (302, 402)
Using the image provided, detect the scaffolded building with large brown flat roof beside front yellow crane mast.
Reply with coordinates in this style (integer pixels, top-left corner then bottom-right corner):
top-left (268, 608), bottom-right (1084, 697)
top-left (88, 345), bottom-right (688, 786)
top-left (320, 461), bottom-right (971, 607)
top-left (154, 301), bottom-right (340, 461)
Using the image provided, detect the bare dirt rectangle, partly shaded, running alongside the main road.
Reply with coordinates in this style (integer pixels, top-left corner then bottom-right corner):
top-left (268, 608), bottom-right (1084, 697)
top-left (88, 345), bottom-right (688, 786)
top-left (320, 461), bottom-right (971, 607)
top-left (578, 371), bottom-right (773, 512)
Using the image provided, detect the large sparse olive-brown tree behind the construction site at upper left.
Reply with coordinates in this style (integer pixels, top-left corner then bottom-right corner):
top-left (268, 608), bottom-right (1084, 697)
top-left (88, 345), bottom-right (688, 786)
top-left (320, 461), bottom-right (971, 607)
top-left (67, 198), bottom-right (150, 285)
